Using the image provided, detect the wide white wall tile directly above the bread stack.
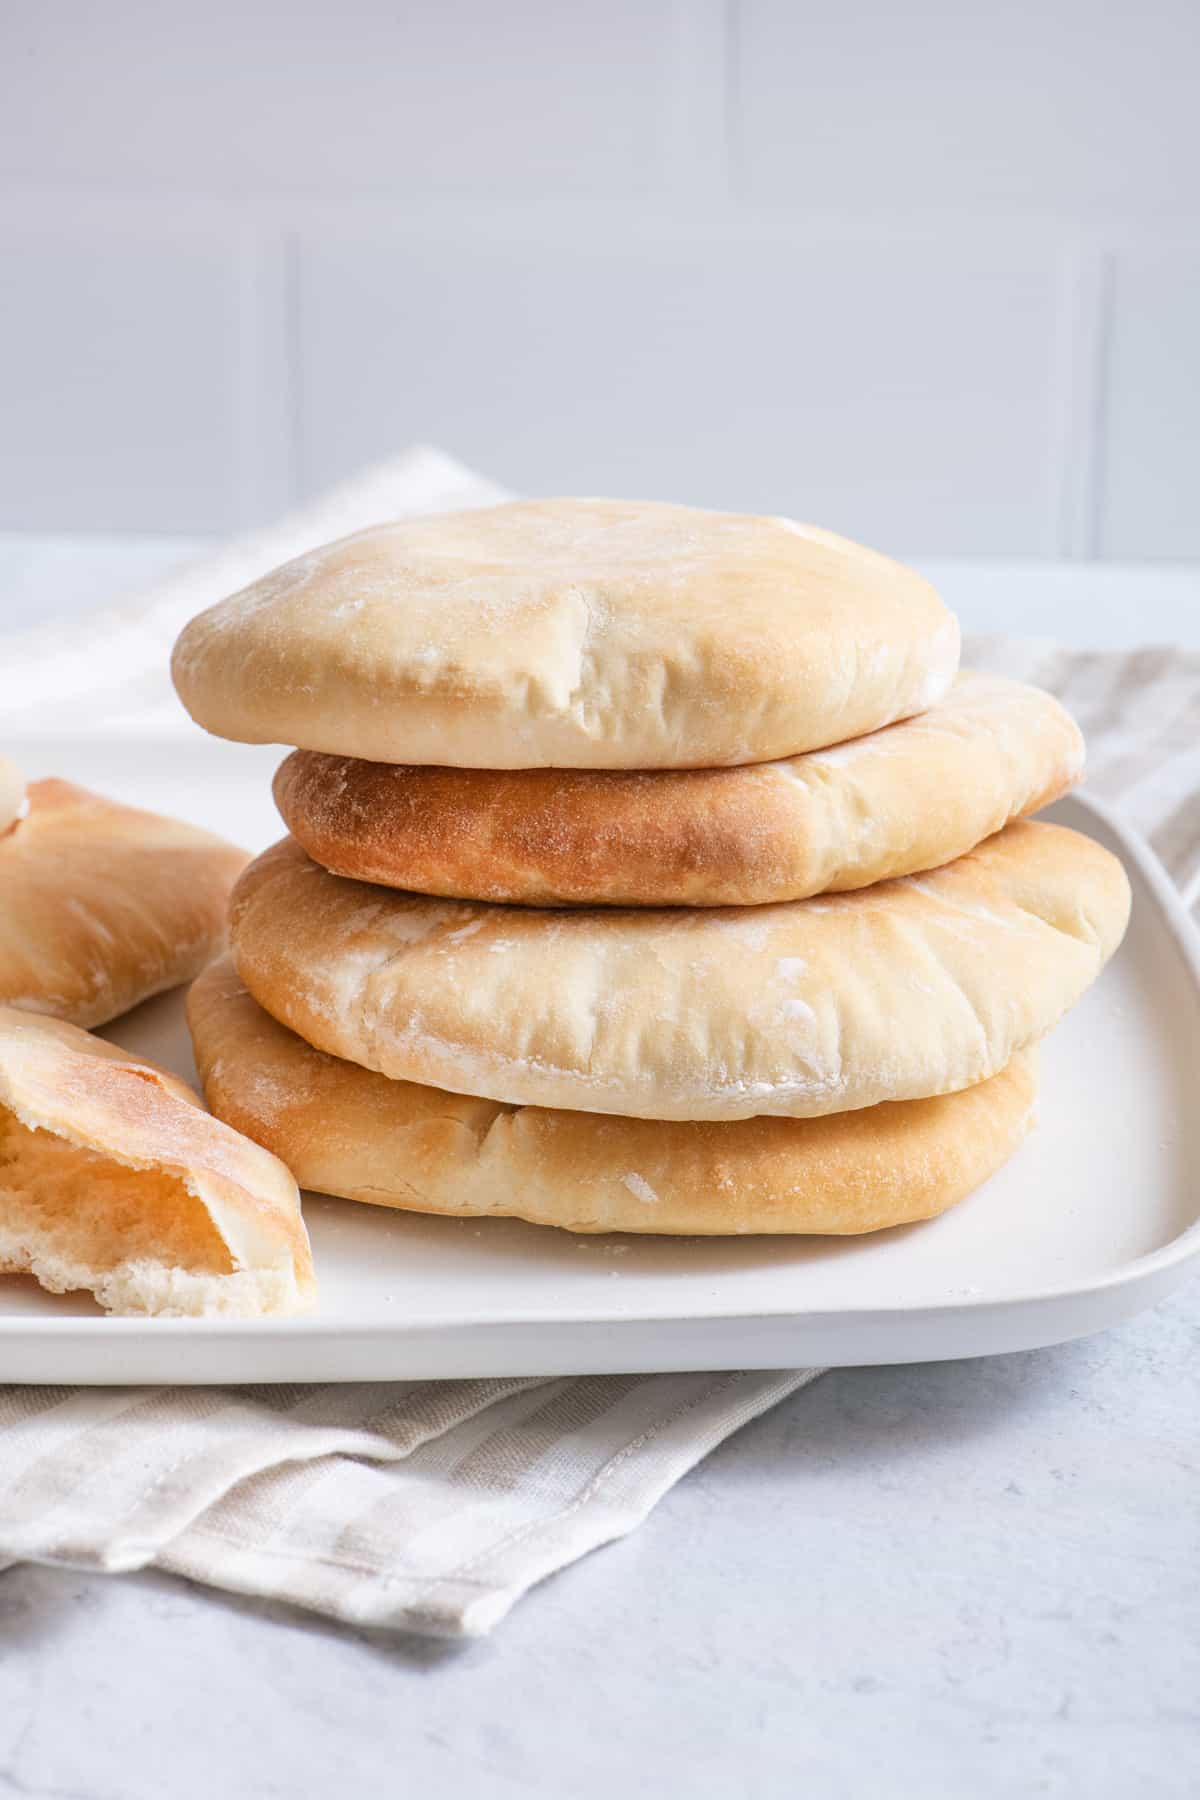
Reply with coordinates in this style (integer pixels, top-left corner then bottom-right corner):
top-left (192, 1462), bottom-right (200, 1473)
top-left (297, 238), bottom-right (1056, 554)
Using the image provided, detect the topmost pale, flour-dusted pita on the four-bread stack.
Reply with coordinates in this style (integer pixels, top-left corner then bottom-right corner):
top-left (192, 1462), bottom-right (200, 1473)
top-left (173, 500), bottom-right (959, 769)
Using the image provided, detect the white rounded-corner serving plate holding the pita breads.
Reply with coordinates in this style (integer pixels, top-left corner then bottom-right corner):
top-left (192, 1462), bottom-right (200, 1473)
top-left (0, 733), bottom-right (1200, 1384)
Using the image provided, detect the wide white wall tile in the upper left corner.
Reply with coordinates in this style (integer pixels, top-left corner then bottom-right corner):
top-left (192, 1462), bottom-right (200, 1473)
top-left (5, 0), bottom-right (669, 193)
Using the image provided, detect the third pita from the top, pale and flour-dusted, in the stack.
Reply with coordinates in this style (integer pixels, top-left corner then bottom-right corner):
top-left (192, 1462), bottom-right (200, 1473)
top-left (230, 823), bottom-right (1130, 1120)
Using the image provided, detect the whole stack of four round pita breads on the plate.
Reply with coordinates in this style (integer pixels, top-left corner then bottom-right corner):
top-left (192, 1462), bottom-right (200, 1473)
top-left (175, 500), bottom-right (1130, 1233)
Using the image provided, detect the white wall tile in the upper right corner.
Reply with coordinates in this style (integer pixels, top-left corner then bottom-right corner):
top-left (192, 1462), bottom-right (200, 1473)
top-left (738, 0), bottom-right (1200, 221)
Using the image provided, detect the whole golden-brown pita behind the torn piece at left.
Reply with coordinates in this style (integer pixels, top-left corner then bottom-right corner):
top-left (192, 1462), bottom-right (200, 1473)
top-left (0, 781), bottom-right (246, 1026)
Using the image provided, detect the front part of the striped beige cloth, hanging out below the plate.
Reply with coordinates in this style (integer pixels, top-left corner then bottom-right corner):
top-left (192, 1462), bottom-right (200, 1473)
top-left (0, 1370), bottom-right (819, 1638)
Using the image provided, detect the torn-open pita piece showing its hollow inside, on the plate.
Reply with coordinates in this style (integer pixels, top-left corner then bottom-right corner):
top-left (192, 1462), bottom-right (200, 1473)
top-left (0, 1006), bottom-right (315, 1316)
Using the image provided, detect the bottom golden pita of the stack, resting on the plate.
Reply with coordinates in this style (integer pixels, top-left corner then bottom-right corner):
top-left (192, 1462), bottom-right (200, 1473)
top-left (187, 958), bottom-right (1034, 1235)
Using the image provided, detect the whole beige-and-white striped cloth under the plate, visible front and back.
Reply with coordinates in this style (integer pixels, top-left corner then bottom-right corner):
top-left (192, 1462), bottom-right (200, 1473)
top-left (0, 452), bottom-right (1200, 1636)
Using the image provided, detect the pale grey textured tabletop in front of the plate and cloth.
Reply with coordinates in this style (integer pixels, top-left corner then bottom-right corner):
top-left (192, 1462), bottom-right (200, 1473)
top-left (0, 1283), bottom-right (1200, 1800)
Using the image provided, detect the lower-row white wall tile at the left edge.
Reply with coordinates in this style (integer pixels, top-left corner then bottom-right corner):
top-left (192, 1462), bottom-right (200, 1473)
top-left (0, 214), bottom-right (241, 531)
